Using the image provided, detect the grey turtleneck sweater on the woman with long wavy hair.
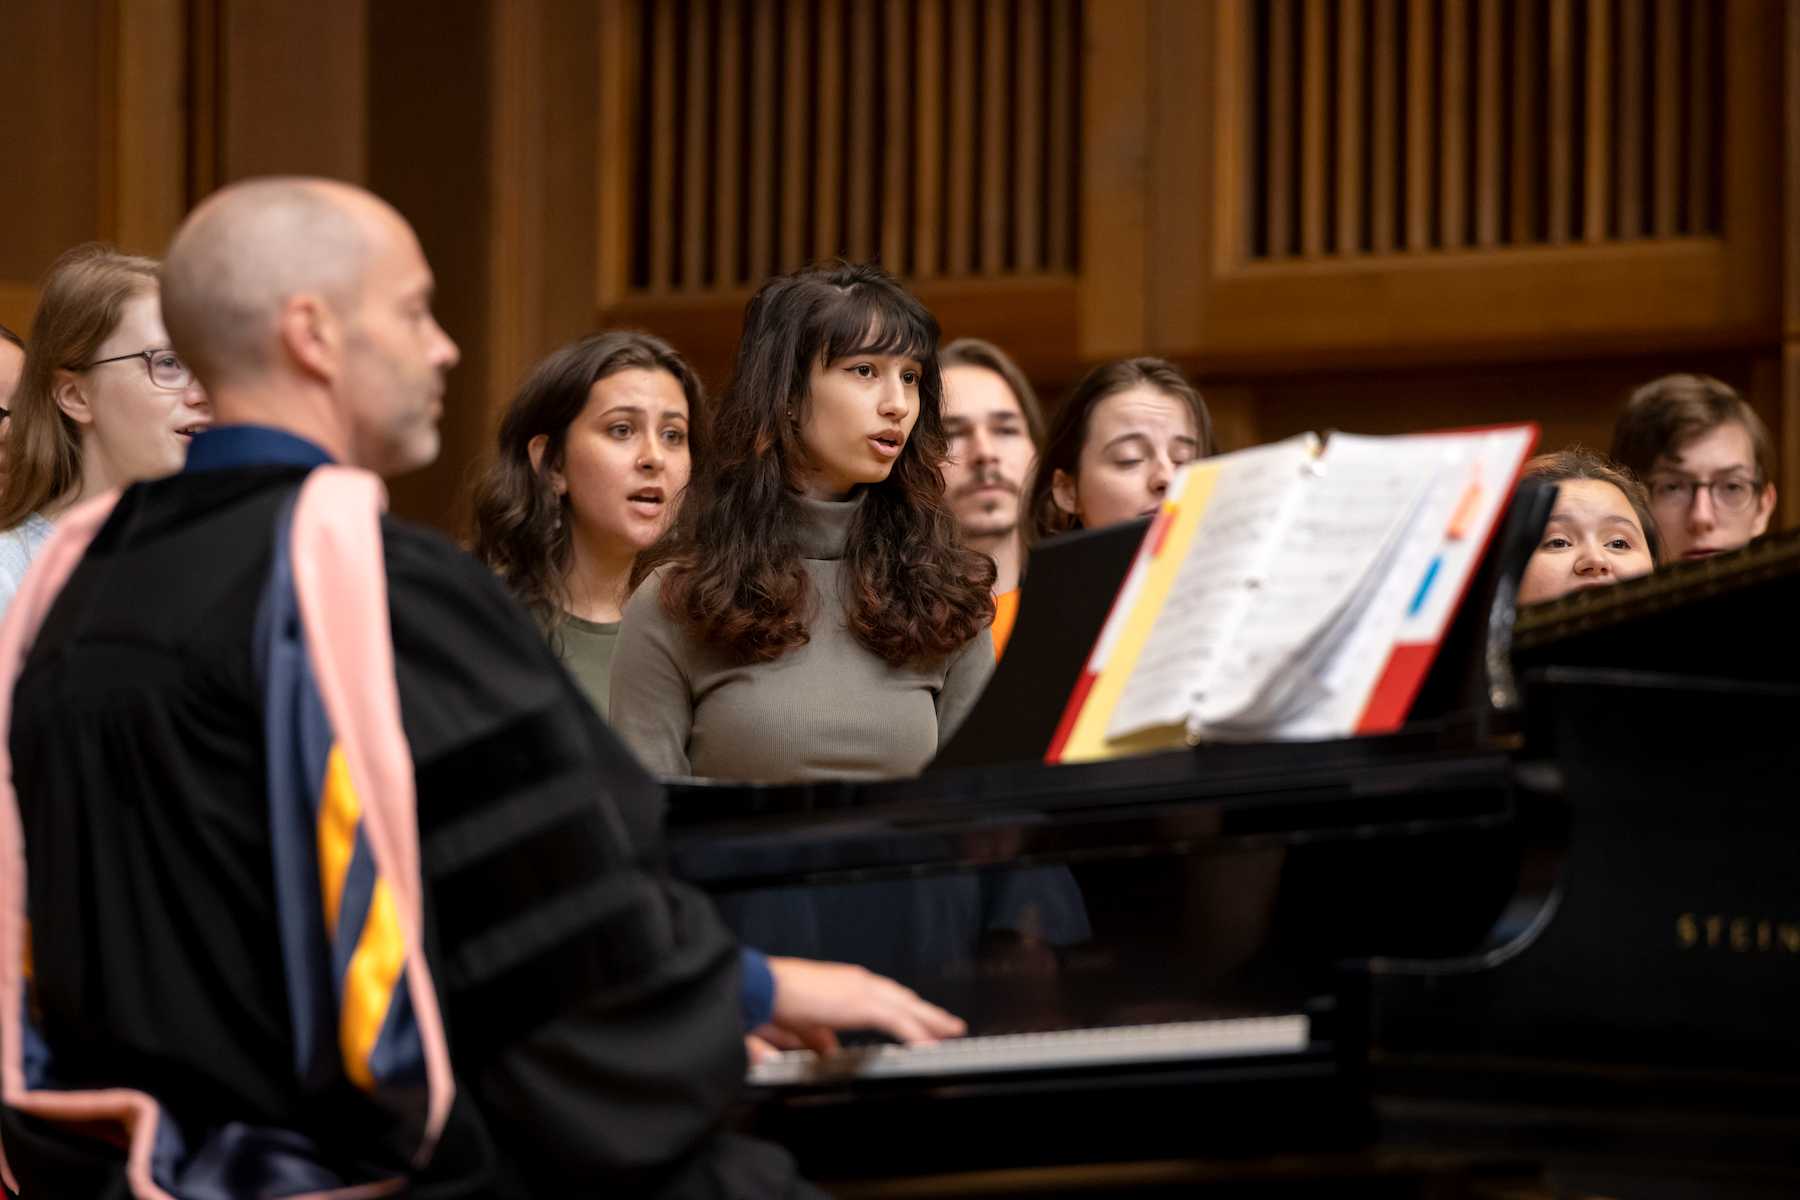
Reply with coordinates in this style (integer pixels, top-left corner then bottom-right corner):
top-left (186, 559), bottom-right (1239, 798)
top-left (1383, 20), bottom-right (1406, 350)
top-left (610, 498), bottom-right (994, 783)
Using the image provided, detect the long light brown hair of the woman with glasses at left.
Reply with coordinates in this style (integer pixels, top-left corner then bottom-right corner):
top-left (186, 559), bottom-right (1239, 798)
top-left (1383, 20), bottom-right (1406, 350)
top-left (0, 241), bottom-right (157, 529)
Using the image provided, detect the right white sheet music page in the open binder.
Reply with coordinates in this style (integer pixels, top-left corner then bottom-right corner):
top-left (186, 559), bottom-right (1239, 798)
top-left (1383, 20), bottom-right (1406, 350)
top-left (1193, 434), bottom-right (1445, 729)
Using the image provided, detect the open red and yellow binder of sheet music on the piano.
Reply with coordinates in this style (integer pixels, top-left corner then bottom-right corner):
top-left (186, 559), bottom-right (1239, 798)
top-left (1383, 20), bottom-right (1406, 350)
top-left (1046, 425), bottom-right (1537, 763)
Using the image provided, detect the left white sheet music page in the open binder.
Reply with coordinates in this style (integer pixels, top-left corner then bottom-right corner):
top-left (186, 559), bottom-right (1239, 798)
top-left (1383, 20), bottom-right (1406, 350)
top-left (1107, 434), bottom-right (1319, 739)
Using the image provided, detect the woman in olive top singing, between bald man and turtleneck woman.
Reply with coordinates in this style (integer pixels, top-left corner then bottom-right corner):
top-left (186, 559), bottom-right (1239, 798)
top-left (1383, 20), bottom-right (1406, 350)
top-left (472, 333), bottom-right (706, 716)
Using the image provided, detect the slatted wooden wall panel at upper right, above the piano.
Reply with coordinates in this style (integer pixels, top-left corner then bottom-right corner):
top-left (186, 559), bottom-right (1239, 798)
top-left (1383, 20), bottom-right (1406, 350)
top-left (1152, 0), bottom-right (1780, 371)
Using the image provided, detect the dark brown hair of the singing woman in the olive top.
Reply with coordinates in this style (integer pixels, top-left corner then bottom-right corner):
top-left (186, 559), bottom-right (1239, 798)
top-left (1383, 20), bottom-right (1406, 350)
top-left (470, 333), bottom-right (706, 631)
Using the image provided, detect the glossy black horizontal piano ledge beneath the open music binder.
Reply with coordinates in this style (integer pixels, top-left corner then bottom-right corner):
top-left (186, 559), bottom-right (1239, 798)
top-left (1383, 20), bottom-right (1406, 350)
top-left (670, 729), bottom-right (1514, 889)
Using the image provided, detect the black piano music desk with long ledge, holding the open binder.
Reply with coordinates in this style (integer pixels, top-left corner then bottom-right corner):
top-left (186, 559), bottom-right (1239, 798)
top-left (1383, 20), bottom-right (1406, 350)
top-left (670, 480), bottom-right (1555, 883)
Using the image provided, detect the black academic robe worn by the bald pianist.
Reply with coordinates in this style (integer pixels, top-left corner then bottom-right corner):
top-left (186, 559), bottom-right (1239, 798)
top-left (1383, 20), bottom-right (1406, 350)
top-left (0, 466), bottom-right (797, 1196)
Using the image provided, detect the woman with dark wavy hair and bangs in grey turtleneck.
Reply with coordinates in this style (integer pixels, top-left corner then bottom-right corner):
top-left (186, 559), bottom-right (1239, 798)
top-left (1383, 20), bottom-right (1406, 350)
top-left (612, 264), bottom-right (994, 781)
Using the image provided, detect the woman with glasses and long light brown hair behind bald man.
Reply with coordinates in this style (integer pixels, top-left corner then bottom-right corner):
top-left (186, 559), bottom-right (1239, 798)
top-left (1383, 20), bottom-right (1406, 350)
top-left (0, 245), bottom-right (212, 613)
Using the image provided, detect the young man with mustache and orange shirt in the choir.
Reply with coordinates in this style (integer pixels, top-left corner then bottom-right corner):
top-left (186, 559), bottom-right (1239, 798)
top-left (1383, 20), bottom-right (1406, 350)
top-left (941, 338), bottom-right (1044, 658)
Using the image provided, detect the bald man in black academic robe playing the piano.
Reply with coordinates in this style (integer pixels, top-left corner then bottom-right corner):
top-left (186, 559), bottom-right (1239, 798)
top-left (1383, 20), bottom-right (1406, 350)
top-left (0, 180), bottom-right (959, 1198)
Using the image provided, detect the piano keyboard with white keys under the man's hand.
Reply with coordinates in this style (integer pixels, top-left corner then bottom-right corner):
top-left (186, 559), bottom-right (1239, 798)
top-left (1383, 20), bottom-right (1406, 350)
top-left (749, 1015), bottom-right (1310, 1087)
